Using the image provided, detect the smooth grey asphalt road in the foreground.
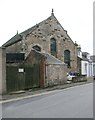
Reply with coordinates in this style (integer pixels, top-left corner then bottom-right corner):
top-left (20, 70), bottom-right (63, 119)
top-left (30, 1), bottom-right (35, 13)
top-left (2, 83), bottom-right (93, 118)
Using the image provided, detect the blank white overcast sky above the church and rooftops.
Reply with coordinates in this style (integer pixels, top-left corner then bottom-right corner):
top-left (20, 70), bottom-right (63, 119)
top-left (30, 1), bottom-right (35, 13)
top-left (0, 0), bottom-right (93, 55)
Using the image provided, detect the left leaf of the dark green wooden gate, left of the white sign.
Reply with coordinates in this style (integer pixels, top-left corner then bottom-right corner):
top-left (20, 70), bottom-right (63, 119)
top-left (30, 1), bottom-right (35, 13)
top-left (6, 66), bottom-right (25, 92)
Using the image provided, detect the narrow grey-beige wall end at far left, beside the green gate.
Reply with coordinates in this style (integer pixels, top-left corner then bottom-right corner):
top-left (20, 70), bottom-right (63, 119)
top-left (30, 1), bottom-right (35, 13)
top-left (0, 48), bottom-right (6, 94)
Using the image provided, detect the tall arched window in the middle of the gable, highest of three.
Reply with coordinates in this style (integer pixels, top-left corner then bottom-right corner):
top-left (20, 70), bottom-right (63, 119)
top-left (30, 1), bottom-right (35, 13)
top-left (50, 38), bottom-right (57, 57)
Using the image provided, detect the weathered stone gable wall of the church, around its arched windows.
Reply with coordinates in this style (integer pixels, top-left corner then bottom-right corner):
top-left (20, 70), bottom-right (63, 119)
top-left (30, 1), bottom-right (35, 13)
top-left (4, 13), bottom-right (77, 72)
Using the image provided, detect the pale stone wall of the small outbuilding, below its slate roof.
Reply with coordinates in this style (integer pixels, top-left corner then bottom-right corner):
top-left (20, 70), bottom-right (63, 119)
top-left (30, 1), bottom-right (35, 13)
top-left (45, 64), bottom-right (67, 86)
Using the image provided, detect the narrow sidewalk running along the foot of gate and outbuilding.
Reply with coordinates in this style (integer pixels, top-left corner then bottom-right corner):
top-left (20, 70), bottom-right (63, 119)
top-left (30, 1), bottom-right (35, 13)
top-left (0, 79), bottom-right (93, 101)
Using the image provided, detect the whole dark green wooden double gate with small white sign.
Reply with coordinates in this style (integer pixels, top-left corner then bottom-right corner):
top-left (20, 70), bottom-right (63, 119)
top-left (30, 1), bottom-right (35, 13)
top-left (6, 64), bottom-right (40, 92)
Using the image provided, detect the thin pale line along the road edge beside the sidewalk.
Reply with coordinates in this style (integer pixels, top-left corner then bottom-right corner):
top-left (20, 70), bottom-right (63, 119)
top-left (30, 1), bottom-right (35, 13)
top-left (0, 83), bottom-right (92, 104)
